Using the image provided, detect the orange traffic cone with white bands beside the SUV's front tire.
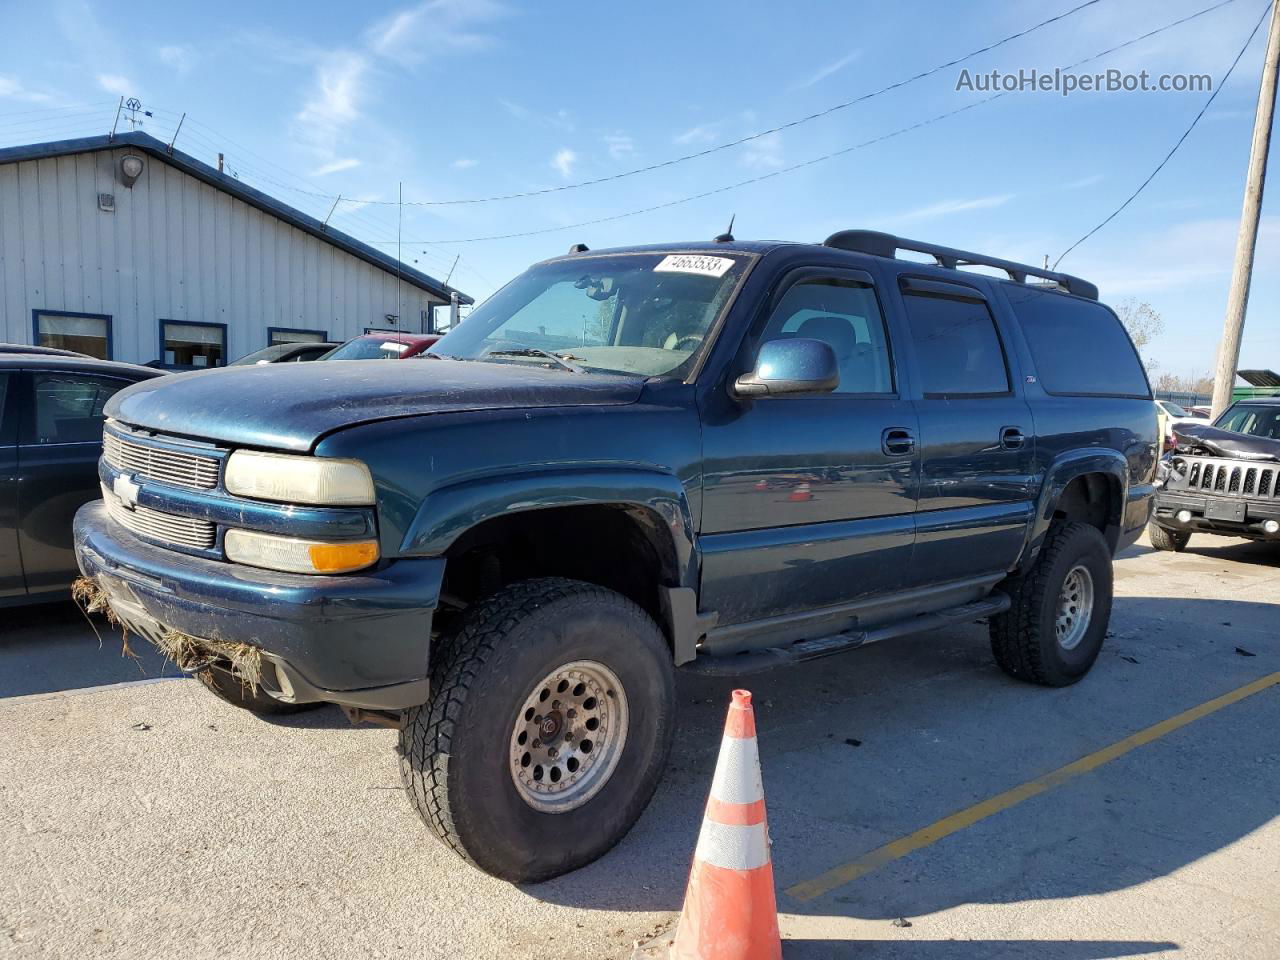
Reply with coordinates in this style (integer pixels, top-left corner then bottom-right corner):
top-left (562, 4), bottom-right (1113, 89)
top-left (671, 690), bottom-right (782, 960)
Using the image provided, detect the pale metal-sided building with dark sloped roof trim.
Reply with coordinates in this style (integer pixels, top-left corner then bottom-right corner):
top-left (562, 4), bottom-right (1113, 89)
top-left (0, 133), bottom-right (471, 370)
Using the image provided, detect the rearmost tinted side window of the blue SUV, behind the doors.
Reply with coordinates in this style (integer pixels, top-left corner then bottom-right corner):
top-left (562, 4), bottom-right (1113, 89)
top-left (1005, 284), bottom-right (1151, 399)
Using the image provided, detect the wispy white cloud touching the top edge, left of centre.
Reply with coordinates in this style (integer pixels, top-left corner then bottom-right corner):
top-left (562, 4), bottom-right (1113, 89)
top-left (365, 0), bottom-right (507, 67)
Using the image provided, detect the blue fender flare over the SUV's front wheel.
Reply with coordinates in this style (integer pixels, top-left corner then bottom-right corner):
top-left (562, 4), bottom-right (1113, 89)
top-left (401, 467), bottom-right (700, 589)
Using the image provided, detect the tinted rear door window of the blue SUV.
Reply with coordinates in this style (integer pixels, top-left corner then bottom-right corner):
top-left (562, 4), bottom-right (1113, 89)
top-left (902, 289), bottom-right (1010, 397)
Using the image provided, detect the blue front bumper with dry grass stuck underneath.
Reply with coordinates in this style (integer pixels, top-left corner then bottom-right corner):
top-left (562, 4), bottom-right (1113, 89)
top-left (76, 500), bottom-right (444, 709)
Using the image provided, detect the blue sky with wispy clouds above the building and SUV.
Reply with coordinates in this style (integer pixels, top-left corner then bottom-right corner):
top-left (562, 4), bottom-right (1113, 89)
top-left (0, 0), bottom-right (1280, 375)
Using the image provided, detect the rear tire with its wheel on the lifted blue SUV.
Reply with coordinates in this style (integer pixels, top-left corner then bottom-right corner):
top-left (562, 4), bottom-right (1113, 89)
top-left (991, 522), bottom-right (1112, 686)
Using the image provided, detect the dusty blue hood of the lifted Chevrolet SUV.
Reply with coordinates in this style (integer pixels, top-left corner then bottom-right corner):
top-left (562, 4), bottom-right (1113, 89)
top-left (106, 358), bottom-right (644, 451)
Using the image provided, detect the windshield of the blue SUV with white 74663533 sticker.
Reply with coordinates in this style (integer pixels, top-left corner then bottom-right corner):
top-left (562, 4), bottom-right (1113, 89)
top-left (430, 253), bottom-right (749, 376)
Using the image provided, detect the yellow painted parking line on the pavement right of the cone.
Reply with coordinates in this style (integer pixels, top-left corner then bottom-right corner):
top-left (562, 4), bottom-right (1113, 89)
top-left (785, 673), bottom-right (1280, 900)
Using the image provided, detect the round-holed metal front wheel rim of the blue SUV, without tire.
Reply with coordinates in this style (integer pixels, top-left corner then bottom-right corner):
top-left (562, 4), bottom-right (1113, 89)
top-left (511, 660), bottom-right (627, 813)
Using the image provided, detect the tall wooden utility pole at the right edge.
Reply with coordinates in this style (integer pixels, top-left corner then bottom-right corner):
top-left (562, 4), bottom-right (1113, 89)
top-left (1211, 0), bottom-right (1280, 420)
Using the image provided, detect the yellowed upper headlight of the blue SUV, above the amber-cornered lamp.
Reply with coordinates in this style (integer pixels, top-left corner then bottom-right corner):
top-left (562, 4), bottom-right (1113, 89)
top-left (227, 451), bottom-right (374, 507)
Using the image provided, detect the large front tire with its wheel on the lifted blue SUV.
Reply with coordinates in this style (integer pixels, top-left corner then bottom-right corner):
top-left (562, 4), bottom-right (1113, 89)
top-left (399, 579), bottom-right (675, 883)
